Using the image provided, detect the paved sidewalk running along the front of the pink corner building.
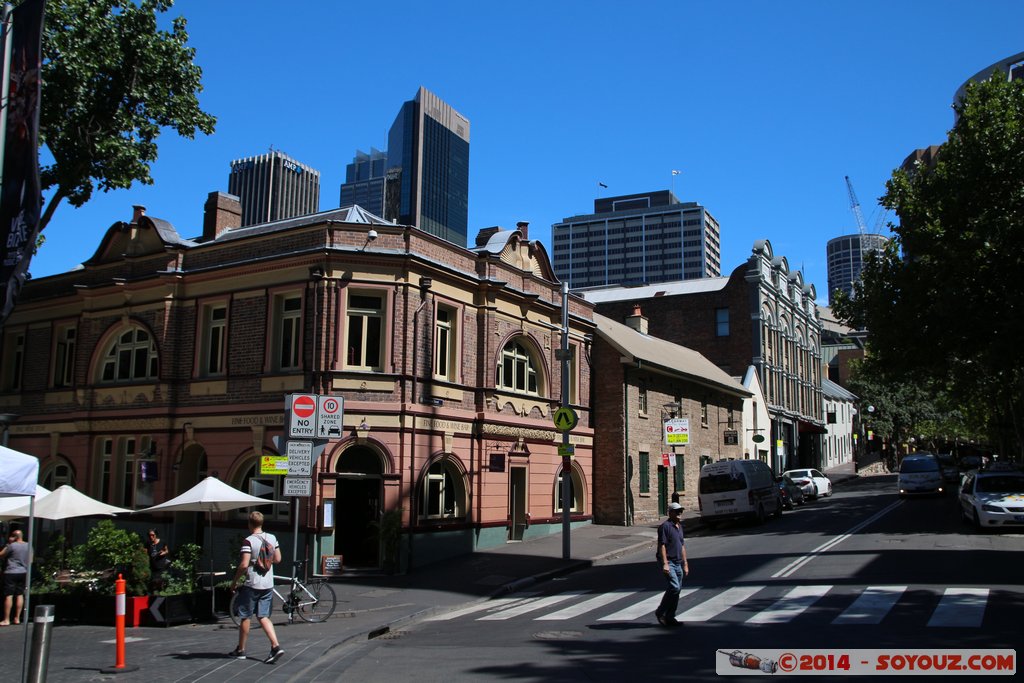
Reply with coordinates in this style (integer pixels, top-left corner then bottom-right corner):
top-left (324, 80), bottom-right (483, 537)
top-left (0, 463), bottom-right (857, 683)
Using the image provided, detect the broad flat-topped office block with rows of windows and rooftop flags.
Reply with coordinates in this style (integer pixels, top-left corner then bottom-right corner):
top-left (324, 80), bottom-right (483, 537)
top-left (551, 189), bottom-right (722, 290)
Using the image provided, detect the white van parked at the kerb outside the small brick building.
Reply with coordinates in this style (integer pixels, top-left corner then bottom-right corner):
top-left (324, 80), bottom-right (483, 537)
top-left (697, 460), bottom-right (782, 523)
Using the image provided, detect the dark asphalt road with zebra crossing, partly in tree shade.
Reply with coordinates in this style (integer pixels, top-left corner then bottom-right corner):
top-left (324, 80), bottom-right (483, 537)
top-left (304, 476), bottom-right (1024, 682)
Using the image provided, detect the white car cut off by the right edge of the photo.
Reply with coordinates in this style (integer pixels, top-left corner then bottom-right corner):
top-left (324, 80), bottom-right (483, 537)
top-left (959, 465), bottom-right (1024, 530)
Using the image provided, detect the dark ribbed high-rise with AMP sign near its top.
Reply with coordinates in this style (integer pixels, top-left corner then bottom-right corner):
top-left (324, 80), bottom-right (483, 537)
top-left (227, 150), bottom-right (319, 227)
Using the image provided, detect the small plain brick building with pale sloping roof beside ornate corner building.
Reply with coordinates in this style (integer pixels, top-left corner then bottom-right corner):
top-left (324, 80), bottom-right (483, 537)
top-left (593, 306), bottom-right (752, 526)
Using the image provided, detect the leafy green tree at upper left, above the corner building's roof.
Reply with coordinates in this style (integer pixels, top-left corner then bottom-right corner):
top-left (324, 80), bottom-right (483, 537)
top-left (33, 0), bottom-right (216, 228)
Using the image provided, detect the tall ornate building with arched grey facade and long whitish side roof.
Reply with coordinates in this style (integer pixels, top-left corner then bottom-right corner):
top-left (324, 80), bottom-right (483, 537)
top-left (580, 240), bottom-right (825, 472)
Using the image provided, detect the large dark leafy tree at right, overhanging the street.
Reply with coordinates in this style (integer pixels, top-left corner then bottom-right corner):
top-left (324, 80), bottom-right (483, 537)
top-left (837, 74), bottom-right (1024, 456)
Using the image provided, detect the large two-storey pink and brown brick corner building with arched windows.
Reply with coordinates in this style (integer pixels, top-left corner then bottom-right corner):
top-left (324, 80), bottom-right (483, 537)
top-left (0, 198), bottom-right (593, 567)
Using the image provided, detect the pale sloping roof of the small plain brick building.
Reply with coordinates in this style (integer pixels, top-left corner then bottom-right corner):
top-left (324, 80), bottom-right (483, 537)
top-left (594, 313), bottom-right (753, 398)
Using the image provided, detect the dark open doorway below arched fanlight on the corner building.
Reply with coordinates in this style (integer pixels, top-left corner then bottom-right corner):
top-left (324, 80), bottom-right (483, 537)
top-left (335, 477), bottom-right (381, 568)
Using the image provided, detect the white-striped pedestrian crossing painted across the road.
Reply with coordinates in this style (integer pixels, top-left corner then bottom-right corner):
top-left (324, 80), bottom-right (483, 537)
top-left (425, 585), bottom-right (991, 628)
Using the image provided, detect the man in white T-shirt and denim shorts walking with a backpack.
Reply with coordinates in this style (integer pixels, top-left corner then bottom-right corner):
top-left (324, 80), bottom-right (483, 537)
top-left (228, 510), bottom-right (285, 664)
